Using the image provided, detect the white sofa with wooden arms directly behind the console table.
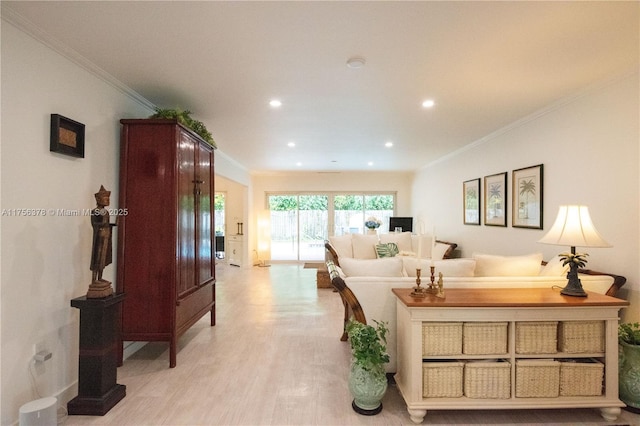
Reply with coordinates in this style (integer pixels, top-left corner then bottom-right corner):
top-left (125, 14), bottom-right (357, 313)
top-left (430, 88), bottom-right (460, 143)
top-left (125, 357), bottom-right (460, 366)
top-left (327, 253), bottom-right (626, 372)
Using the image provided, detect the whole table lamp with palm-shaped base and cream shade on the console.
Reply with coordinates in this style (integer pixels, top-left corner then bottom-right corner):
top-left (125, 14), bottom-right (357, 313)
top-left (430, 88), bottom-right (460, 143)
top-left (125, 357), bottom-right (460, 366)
top-left (538, 206), bottom-right (611, 297)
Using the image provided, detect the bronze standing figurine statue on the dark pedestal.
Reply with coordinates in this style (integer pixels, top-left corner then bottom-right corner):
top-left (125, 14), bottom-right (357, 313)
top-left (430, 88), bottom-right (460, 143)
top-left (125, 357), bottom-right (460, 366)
top-left (87, 185), bottom-right (115, 299)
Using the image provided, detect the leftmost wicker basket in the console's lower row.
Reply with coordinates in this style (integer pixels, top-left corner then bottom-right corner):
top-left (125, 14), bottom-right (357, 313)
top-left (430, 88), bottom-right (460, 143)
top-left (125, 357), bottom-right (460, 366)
top-left (422, 360), bottom-right (464, 398)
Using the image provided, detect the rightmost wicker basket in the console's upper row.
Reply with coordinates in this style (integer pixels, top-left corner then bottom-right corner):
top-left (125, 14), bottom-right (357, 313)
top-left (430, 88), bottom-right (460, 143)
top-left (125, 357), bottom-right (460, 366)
top-left (558, 321), bottom-right (604, 353)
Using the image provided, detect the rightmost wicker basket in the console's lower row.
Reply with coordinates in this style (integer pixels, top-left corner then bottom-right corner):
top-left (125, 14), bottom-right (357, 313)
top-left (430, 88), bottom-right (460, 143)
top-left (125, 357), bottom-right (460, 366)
top-left (560, 358), bottom-right (604, 396)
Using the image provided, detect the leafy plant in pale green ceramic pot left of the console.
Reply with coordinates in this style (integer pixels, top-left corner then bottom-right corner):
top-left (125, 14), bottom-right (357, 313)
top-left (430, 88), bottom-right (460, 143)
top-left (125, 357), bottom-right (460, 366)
top-left (346, 318), bottom-right (389, 416)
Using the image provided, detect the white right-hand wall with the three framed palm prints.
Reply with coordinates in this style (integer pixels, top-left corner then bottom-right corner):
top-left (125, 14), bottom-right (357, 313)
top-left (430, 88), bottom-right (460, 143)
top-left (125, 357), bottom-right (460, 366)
top-left (412, 73), bottom-right (640, 319)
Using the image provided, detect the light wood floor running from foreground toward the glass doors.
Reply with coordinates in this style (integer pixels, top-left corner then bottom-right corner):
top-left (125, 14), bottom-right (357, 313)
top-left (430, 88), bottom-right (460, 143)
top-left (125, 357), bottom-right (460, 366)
top-left (64, 264), bottom-right (640, 425)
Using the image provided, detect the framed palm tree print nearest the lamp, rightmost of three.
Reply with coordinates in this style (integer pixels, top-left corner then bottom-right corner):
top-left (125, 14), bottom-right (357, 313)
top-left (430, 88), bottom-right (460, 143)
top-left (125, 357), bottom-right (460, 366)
top-left (511, 164), bottom-right (543, 229)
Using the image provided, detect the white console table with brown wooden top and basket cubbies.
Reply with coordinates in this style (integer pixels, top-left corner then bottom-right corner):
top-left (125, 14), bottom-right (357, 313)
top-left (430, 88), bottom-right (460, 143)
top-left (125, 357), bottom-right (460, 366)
top-left (392, 288), bottom-right (629, 423)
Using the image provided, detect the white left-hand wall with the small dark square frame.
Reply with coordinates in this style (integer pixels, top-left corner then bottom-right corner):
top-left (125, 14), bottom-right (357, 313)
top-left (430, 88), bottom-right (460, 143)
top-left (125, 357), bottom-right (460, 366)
top-left (0, 21), bottom-right (151, 424)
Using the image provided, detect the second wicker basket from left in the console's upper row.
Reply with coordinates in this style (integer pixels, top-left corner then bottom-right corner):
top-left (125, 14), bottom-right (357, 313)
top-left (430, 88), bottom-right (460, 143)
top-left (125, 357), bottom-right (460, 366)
top-left (462, 322), bottom-right (507, 355)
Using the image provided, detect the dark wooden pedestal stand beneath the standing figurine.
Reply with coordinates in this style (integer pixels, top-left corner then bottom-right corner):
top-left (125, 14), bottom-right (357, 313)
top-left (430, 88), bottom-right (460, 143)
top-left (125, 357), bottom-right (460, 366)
top-left (67, 293), bottom-right (126, 416)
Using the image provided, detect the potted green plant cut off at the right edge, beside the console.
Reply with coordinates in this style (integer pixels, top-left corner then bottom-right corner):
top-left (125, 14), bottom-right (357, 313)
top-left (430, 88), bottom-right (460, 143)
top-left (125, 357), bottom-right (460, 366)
top-left (618, 322), bottom-right (640, 412)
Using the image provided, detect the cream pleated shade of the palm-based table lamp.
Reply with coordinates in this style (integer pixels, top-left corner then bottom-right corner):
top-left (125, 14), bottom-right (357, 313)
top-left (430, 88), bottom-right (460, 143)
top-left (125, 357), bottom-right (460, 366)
top-left (538, 206), bottom-right (611, 247)
